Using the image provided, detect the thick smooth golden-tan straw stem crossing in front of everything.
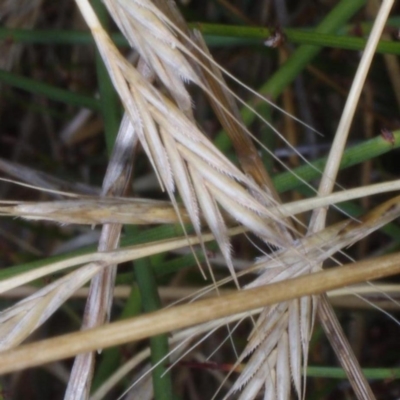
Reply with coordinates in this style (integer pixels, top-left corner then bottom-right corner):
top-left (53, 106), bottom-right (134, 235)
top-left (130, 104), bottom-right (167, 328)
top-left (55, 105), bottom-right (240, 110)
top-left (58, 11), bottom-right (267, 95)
top-left (0, 254), bottom-right (400, 373)
